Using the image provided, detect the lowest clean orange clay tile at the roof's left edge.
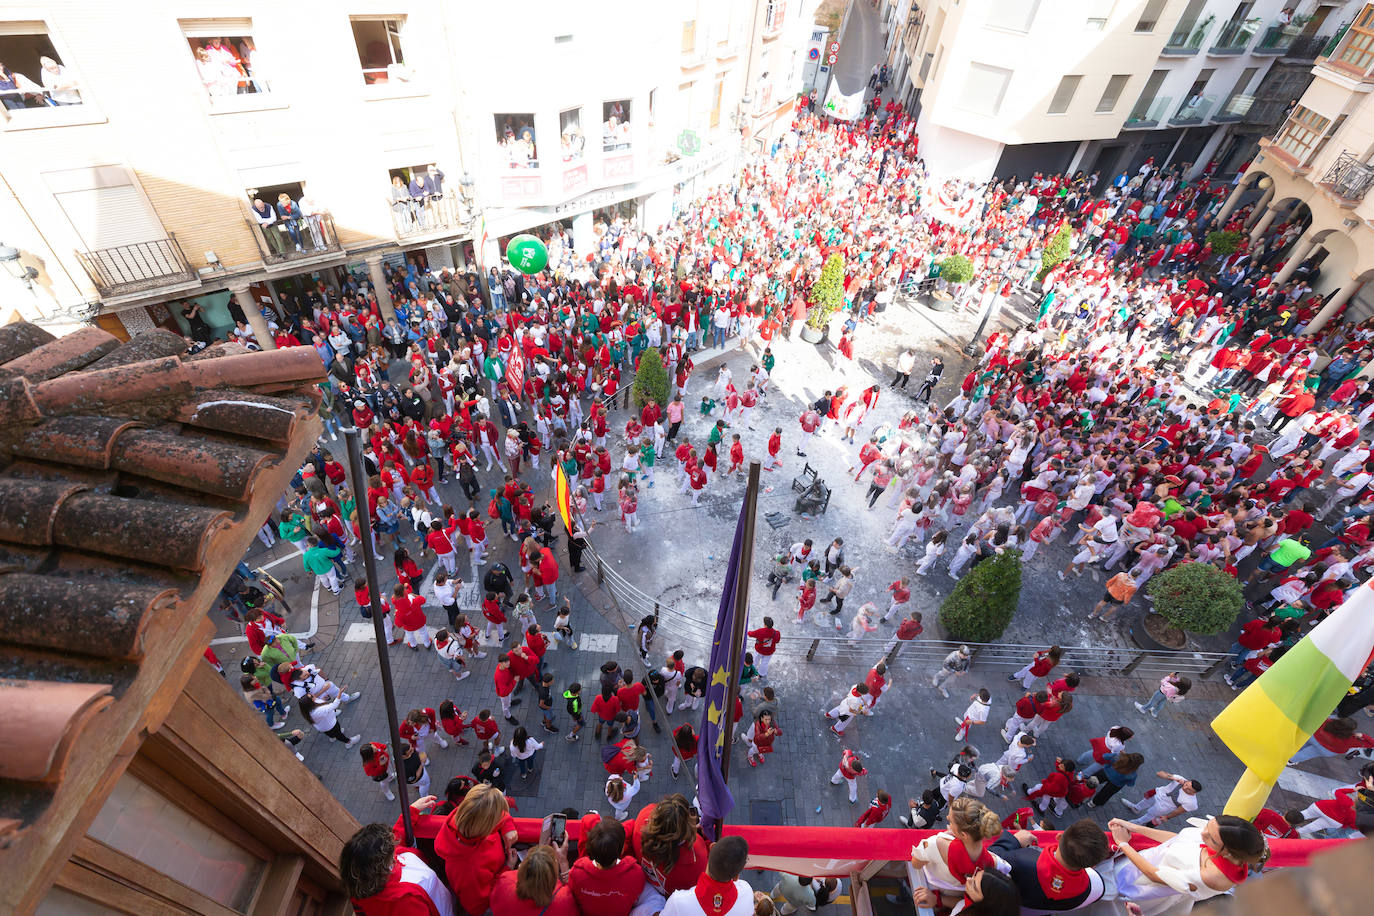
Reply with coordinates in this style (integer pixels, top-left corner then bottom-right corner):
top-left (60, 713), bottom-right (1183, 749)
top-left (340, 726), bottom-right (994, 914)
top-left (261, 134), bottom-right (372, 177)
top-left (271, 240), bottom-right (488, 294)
top-left (0, 680), bottom-right (114, 783)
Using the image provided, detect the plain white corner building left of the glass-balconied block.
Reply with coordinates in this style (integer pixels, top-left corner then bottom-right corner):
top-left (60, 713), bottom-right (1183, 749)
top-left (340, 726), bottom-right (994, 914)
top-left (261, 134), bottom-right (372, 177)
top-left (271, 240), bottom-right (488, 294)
top-left (885, 0), bottom-right (1187, 180)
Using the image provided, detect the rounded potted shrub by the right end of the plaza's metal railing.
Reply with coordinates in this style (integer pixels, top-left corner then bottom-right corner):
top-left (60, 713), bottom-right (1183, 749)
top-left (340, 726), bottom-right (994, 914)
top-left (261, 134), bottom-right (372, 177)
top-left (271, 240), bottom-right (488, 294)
top-left (1132, 563), bottom-right (1245, 650)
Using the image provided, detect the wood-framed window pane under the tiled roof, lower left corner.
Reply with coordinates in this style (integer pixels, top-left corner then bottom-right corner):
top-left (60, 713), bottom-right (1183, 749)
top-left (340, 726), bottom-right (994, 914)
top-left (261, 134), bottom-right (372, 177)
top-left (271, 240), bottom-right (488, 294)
top-left (87, 773), bottom-right (267, 912)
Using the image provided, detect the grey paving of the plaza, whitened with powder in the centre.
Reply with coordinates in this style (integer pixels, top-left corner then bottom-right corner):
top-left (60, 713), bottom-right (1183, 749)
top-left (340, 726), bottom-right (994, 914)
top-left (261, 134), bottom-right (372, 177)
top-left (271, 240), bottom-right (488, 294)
top-left (216, 292), bottom-right (1355, 827)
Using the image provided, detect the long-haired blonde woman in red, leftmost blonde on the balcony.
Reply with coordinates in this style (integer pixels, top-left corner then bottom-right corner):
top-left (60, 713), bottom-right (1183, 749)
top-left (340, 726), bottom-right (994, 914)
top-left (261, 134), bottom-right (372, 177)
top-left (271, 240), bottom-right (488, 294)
top-left (434, 783), bottom-right (511, 913)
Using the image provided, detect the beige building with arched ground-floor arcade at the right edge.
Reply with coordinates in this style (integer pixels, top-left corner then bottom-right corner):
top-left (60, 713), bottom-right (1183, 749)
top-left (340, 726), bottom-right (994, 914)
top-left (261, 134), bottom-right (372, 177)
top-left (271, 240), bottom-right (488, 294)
top-left (1223, 3), bottom-right (1374, 331)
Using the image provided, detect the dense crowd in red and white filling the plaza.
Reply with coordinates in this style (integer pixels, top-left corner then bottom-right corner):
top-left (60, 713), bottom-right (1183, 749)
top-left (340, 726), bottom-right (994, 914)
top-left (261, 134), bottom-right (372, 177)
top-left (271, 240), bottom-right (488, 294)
top-left (199, 82), bottom-right (1374, 916)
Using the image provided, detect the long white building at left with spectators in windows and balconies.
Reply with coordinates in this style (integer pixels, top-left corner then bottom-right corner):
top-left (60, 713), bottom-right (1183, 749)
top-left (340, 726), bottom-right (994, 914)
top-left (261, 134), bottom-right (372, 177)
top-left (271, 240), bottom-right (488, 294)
top-left (0, 0), bottom-right (813, 339)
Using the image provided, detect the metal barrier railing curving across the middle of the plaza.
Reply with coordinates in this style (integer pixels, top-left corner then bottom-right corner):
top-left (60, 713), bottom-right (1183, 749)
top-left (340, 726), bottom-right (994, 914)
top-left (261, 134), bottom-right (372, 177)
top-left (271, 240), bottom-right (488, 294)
top-left (584, 541), bottom-right (1231, 680)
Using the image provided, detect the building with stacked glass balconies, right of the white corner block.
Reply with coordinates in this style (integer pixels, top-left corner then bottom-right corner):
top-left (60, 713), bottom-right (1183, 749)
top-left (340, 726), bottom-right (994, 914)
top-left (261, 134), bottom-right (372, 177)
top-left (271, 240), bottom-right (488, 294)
top-left (1080, 0), bottom-right (1360, 186)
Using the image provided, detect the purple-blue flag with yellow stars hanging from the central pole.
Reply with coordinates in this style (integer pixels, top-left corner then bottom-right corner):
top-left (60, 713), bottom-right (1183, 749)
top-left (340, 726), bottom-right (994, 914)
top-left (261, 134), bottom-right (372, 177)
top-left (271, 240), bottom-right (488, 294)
top-left (697, 500), bottom-right (749, 835)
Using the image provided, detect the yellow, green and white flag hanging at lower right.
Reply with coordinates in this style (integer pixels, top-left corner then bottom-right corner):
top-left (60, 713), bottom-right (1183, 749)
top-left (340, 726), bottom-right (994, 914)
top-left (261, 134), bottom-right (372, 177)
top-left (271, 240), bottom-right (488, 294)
top-left (1212, 584), bottom-right (1374, 818)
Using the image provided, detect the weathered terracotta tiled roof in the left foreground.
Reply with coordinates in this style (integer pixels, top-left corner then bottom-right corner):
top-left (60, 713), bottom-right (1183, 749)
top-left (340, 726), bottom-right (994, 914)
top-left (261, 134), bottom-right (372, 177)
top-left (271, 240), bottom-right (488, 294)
top-left (0, 323), bottom-right (324, 847)
